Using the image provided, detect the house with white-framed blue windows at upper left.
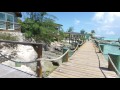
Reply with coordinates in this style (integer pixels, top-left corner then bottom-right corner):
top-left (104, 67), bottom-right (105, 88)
top-left (0, 12), bottom-right (22, 32)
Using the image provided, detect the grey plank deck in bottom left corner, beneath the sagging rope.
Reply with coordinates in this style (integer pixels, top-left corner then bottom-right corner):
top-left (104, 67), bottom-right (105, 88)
top-left (0, 64), bottom-right (36, 78)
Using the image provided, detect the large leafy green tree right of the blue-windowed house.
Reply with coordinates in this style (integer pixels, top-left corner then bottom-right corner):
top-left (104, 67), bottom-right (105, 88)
top-left (21, 12), bottom-right (64, 44)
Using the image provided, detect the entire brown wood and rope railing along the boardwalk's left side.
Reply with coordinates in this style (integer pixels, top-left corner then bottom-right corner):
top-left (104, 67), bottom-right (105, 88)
top-left (0, 40), bottom-right (85, 78)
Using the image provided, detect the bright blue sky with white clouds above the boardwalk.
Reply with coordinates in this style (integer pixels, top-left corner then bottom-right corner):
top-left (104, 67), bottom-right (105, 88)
top-left (22, 12), bottom-right (120, 37)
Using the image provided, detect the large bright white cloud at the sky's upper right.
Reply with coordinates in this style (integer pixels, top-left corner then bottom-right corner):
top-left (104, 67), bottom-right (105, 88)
top-left (92, 12), bottom-right (120, 35)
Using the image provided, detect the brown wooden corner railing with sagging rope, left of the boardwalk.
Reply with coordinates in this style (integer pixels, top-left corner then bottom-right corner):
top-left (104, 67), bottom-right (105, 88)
top-left (0, 40), bottom-right (42, 77)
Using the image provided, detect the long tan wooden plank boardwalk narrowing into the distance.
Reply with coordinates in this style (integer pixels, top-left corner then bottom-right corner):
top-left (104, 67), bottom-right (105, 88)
top-left (48, 41), bottom-right (118, 78)
